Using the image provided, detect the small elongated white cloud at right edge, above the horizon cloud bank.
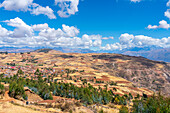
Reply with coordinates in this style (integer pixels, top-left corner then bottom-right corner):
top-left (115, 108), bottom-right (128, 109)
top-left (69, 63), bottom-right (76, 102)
top-left (147, 20), bottom-right (170, 29)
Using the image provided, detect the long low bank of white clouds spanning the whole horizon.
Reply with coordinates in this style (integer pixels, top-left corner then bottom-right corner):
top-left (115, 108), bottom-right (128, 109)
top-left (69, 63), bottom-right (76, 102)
top-left (0, 17), bottom-right (170, 50)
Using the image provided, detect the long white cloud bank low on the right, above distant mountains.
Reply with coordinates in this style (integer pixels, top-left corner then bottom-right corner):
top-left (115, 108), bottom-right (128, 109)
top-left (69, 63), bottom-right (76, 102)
top-left (101, 33), bottom-right (170, 50)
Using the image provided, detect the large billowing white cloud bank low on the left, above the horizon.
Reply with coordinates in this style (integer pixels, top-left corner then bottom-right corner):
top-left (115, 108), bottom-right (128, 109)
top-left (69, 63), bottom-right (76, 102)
top-left (0, 17), bottom-right (111, 48)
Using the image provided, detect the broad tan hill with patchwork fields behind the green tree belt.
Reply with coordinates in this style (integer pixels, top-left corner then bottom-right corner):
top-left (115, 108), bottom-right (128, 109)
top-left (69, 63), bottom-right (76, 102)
top-left (0, 49), bottom-right (170, 95)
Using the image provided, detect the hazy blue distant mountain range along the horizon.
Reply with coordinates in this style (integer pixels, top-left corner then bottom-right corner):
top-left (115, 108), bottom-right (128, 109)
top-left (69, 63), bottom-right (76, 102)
top-left (0, 47), bottom-right (170, 62)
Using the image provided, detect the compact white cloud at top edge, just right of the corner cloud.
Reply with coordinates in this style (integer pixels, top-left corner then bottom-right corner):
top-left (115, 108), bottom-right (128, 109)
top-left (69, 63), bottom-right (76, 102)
top-left (55, 0), bottom-right (79, 17)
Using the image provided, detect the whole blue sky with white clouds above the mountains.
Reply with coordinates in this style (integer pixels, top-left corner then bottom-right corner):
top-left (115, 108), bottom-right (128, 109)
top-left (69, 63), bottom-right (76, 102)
top-left (0, 0), bottom-right (170, 51)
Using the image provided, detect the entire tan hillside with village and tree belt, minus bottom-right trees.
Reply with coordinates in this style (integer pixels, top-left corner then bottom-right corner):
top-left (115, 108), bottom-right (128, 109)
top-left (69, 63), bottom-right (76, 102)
top-left (0, 49), bottom-right (170, 113)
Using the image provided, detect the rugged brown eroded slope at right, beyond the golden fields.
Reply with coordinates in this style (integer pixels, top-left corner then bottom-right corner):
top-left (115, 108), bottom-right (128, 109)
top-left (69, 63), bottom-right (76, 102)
top-left (92, 54), bottom-right (170, 95)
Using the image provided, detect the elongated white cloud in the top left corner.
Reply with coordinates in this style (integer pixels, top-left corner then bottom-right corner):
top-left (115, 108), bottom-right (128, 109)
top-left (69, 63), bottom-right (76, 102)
top-left (0, 0), bottom-right (56, 19)
